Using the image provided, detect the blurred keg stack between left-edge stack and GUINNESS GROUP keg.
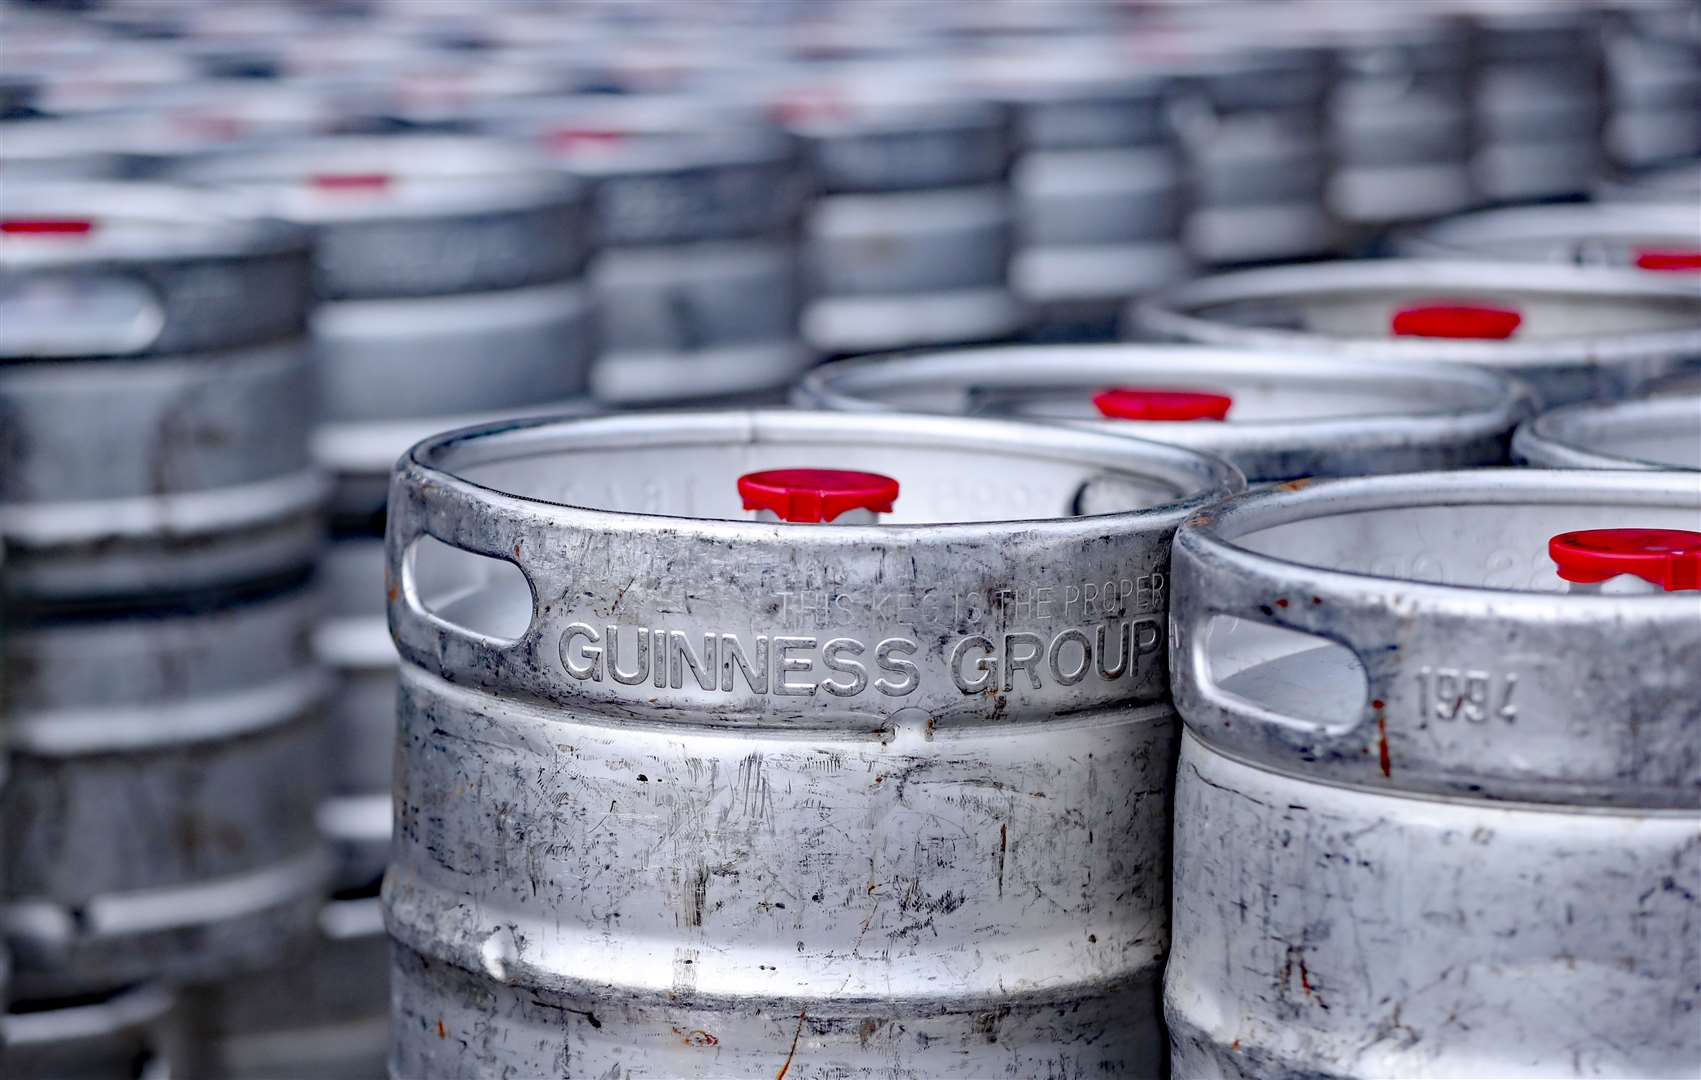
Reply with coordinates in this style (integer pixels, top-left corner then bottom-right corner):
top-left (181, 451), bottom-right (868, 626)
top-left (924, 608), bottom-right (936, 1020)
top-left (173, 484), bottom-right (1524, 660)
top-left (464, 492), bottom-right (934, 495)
top-left (167, 136), bottom-right (594, 1077)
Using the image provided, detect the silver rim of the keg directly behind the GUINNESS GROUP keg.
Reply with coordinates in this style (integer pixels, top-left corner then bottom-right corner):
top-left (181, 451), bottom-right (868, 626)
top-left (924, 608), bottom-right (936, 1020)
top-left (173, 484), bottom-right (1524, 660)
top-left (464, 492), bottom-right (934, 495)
top-left (793, 344), bottom-right (1534, 481)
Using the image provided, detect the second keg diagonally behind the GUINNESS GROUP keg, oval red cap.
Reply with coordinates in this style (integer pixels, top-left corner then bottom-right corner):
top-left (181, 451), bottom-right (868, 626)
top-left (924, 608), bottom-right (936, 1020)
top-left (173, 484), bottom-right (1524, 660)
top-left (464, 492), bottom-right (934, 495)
top-left (1128, 260), bottom-right (1701, 406)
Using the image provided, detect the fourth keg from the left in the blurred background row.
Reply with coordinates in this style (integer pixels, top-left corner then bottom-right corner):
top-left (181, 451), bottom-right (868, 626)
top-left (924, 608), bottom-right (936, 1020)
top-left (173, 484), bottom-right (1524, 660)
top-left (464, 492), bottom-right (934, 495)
top-left (781, 75), bottom-right (1026, 355)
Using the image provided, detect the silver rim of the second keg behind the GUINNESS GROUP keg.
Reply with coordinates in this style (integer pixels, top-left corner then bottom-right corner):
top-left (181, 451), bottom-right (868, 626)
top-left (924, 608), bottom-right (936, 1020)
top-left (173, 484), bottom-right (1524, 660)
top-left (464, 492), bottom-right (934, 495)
top-left (1128, 259), bottom-right (1701, 367)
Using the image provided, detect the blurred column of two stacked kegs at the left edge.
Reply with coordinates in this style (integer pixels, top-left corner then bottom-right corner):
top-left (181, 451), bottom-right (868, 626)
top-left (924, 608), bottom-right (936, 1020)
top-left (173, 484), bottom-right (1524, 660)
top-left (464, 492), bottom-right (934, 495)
top-left (0, 185), bottom-right (328, 1071)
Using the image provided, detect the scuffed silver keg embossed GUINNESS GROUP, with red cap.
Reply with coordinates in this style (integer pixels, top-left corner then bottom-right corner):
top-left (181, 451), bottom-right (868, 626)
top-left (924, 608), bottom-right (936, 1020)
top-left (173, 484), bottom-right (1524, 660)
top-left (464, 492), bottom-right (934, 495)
top-left (384, 412), bottom-right (1242, 1077)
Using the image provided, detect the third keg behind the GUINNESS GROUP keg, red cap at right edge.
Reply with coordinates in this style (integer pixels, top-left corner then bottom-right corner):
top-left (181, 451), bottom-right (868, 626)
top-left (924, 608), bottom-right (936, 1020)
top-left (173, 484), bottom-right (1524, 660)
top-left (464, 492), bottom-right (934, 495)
top-left (1395, 204), bottom-right (1701, 272)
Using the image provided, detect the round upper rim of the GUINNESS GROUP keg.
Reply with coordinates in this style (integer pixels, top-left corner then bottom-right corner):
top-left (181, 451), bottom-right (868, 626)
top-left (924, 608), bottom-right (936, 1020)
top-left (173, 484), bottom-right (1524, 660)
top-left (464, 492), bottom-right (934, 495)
top-left (404, 410), bottom-right (1245, 544)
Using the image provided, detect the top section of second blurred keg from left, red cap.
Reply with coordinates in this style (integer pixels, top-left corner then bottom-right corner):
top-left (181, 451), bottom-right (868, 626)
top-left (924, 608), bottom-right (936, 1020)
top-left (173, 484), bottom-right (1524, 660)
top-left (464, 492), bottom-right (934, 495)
top-left (182, 134), bottom-right (590, 299)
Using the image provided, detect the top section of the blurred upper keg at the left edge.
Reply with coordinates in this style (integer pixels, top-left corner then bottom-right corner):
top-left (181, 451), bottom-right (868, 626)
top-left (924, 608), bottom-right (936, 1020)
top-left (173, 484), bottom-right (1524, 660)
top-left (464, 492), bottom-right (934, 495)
top-left (0, 182), bottom-right (308, 359)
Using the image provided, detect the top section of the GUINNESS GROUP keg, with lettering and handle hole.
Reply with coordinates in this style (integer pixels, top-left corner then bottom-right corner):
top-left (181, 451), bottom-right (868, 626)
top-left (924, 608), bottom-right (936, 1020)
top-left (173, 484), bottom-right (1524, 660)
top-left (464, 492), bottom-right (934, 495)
top-left (386, 412), bottom-right (1243, 731)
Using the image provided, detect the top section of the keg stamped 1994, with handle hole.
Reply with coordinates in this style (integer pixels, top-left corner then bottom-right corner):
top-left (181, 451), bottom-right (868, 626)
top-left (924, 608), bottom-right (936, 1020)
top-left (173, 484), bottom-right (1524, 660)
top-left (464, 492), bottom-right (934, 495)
top-left (1170, 469), bottom-right (1701, 808)
